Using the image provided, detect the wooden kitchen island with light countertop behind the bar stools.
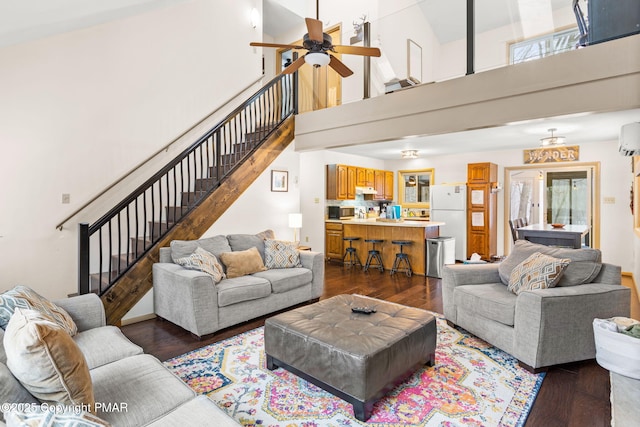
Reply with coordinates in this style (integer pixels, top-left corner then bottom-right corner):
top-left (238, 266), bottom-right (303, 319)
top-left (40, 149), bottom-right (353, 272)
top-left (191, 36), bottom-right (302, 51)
top-left (325, 218), bottom-right (444, 276)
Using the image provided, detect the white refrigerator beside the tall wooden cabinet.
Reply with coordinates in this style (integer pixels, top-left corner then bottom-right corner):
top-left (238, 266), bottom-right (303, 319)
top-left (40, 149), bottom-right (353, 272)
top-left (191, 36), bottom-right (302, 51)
top-left (429, 184), bottom-right (467, 261)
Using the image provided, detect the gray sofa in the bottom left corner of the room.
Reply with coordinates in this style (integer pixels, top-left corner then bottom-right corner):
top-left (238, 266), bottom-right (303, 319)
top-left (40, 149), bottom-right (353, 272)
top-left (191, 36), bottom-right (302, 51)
top-left (0, 294), bottom-right (238, 427)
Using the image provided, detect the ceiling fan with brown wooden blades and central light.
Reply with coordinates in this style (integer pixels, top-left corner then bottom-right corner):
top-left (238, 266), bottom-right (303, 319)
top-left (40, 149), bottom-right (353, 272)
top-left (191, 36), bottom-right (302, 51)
top-left (250, 18), bottom-right (381, 77)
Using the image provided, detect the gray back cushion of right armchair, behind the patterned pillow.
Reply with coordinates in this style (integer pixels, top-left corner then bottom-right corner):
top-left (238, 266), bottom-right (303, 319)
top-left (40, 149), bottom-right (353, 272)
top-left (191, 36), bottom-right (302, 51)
top-left (498, 240), bottom-right (602, 286)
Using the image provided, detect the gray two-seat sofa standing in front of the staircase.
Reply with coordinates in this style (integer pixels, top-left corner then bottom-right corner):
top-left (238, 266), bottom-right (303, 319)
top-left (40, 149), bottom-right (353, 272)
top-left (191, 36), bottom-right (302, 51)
top-left (153, 230), bottom-right (324, 337)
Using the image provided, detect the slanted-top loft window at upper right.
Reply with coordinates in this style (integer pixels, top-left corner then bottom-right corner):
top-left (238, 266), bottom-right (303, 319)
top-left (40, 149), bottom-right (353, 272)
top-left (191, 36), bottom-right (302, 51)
top-left (509, 27), bottom-right (580, 64)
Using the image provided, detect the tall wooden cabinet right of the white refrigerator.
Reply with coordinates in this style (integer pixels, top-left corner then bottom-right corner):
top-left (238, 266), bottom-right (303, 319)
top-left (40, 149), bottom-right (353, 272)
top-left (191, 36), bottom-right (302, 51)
top-left (467, 163), bottom-right (498, 260)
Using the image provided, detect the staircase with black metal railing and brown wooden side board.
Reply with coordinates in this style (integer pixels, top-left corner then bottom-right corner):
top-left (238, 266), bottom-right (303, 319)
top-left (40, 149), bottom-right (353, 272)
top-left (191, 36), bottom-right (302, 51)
top-left (79, 75), bottom-right (296, 324)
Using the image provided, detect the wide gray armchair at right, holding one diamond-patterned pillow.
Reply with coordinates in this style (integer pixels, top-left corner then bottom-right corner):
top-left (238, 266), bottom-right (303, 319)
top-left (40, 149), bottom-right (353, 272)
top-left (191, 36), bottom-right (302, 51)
top-left (442, 240), bottom-right (631, 372)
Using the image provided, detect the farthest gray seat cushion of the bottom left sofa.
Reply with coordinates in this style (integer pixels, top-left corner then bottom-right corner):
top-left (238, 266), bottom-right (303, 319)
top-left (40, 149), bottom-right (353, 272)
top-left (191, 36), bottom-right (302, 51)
top-left (73, 326), bottom-right (143, 369)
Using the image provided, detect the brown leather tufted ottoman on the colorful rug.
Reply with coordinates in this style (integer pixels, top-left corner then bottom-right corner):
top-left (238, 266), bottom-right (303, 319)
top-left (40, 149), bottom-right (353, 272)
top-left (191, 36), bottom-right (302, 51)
top-left (264, 295), bottom-right (436, 421)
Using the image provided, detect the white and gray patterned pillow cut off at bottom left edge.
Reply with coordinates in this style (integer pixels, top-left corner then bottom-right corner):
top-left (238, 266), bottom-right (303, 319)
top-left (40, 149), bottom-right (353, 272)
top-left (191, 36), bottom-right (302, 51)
top-left (7, 407), bottom-right (111, 427)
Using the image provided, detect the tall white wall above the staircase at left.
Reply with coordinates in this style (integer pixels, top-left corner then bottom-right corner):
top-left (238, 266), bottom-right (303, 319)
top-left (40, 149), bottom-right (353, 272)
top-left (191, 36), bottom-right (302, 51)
top-left (0, 0), bottom-right (262, 298)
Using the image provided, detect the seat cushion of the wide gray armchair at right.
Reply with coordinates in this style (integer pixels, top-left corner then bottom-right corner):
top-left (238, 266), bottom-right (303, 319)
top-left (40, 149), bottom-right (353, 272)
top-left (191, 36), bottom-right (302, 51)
top-left (453, 283), bottom-right (518, 326)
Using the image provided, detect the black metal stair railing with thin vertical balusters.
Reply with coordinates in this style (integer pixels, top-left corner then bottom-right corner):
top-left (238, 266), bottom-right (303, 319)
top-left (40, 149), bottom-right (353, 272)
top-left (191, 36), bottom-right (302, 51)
top-left (78, 74), bottom-right (297, 295)
